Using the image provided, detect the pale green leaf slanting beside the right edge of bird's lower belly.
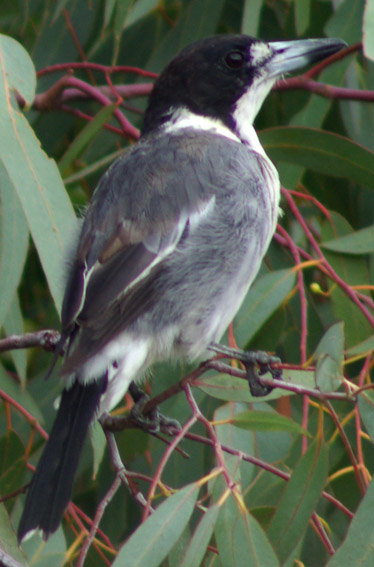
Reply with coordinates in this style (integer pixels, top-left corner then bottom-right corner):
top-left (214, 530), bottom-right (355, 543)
top-left (234, 270), bottom-right (295, 345)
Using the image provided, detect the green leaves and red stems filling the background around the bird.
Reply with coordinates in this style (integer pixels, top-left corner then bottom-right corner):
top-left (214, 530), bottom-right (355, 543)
top-left (0, 0), bottom-right (374, 567)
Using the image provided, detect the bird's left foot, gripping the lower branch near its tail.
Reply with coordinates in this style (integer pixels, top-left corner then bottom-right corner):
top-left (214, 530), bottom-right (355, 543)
top-left (129, 382), bottom-right (181, 435)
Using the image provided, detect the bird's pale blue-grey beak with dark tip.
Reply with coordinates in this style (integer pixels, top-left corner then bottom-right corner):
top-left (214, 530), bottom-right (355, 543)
top-left (266, 38), bottom-right (347, 77)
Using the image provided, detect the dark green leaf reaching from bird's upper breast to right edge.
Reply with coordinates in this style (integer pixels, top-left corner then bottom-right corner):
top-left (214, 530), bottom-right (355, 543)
top-left (260, 127), bottom-right (374, 189)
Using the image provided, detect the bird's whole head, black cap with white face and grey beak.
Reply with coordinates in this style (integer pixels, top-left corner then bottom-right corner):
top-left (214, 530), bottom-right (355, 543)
top-left (142, 35), bottom-right (345, 134)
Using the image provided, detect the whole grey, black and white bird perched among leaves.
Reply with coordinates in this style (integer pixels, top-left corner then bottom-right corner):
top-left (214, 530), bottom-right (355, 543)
top-left (18, 34), bottom-right (345, 541)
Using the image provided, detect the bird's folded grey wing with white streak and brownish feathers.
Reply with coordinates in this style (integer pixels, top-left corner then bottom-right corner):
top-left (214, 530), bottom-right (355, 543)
top-left (61, 130), bottom-right (216, 370)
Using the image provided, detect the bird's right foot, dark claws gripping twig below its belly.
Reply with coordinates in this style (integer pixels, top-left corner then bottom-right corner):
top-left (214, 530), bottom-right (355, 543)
top-left (208, 343), bottom-right (282, 397)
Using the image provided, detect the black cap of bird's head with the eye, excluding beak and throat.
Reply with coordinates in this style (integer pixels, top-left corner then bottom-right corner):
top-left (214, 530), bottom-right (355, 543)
top-left (143, 35), bottom-right (258, 133)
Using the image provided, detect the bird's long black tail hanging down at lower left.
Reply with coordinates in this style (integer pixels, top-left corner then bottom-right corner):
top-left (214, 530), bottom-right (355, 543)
top-left (18, 376), bottom-right (107, 541)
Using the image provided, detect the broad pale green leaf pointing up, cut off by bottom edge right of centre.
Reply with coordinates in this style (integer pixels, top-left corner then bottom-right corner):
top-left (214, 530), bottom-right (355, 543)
top-left (215, 495), bottom-right (279, 567)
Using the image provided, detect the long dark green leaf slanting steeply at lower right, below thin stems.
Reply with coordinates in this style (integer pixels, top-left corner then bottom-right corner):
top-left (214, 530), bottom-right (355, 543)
top-left (268, 439), bottom-right (328, 564)
